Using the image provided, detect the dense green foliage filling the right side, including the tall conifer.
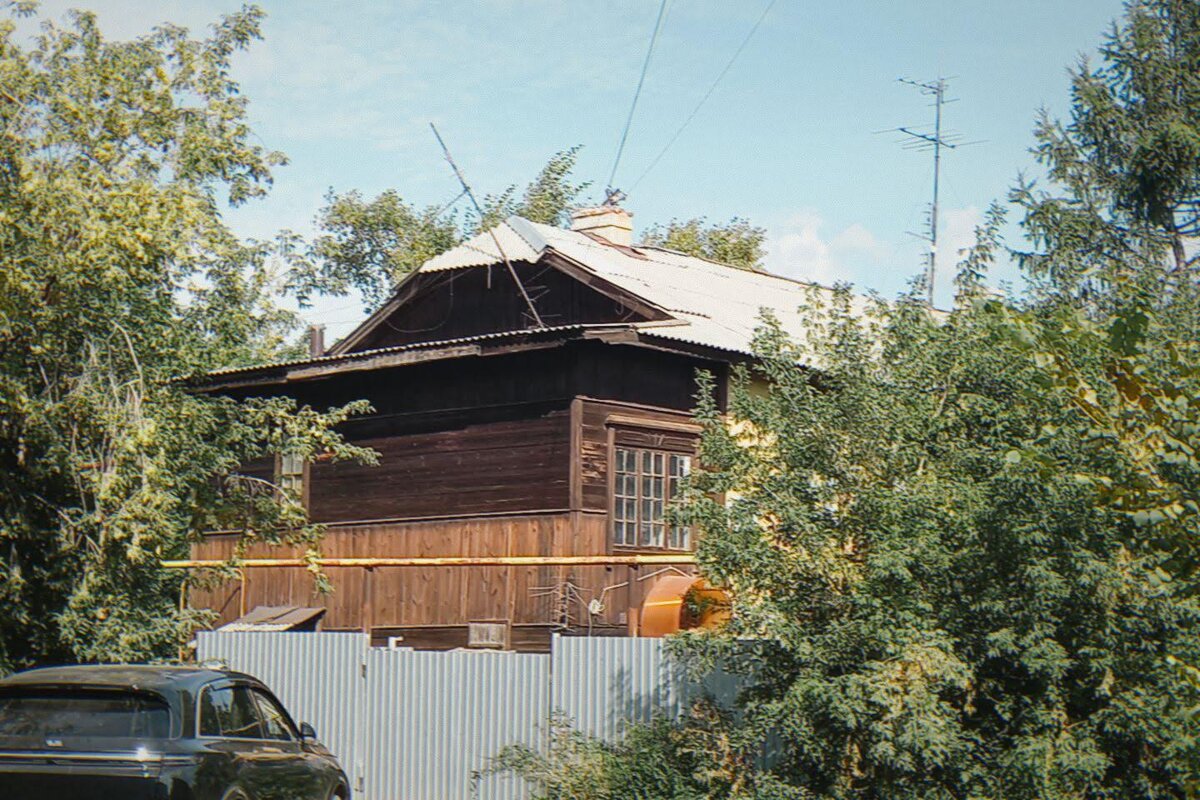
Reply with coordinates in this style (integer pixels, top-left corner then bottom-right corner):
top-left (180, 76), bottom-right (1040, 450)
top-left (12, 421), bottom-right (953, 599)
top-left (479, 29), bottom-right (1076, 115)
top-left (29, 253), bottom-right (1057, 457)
top-left (667, 0), bottom-right (1200, 799)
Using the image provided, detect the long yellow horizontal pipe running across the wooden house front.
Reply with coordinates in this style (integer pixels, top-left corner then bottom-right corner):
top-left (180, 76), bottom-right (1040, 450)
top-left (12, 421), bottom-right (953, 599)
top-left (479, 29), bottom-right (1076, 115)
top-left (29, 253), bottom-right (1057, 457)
top-left (162, 553), bottom-right (696, 570)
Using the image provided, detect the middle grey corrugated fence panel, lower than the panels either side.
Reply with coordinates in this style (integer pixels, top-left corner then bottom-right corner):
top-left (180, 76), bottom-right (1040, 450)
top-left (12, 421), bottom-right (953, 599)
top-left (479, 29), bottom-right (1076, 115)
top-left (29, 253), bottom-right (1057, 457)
top-left (366, 649), bottom-right (550, 800)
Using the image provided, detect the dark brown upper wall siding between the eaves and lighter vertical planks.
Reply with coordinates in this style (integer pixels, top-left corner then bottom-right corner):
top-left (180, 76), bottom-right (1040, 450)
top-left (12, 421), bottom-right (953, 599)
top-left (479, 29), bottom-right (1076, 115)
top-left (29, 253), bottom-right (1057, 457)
top-left (222, 342), bottom-right (720, 522)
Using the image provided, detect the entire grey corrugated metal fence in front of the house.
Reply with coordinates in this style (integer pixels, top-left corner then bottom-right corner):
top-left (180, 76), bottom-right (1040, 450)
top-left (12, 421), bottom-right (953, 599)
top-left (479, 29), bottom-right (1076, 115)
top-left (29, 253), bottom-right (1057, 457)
top-left (197, 632), bottom-right (733, 800)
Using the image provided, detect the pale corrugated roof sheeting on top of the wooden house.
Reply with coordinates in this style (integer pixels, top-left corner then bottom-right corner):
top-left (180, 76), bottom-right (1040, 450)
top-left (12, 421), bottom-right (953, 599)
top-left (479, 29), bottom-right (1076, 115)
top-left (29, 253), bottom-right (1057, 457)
top-left (421, 217), bottom-right (868, 354)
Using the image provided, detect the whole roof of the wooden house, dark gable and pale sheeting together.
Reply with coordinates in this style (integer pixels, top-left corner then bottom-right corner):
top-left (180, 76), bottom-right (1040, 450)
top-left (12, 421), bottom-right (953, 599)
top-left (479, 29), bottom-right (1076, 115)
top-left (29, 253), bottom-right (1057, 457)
top-left (194, 217), bottom-right (883, 385)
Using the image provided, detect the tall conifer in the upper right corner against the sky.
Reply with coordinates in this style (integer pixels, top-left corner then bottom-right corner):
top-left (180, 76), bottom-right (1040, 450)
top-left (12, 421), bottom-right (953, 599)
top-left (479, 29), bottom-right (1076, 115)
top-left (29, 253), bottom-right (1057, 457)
top-left (1014, 0), bottom-right (1200, 291)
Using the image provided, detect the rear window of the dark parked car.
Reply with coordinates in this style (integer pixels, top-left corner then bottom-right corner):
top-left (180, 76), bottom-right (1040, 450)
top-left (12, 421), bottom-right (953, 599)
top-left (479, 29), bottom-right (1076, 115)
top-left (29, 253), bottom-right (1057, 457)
top-left (0, 690), bottom-right (170, 739)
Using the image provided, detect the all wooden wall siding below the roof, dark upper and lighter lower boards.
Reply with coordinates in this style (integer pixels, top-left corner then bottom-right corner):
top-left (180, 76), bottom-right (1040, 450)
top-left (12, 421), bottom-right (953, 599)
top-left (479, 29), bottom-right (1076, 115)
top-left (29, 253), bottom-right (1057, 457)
top-left (191, 340), bottom-right (724, 646)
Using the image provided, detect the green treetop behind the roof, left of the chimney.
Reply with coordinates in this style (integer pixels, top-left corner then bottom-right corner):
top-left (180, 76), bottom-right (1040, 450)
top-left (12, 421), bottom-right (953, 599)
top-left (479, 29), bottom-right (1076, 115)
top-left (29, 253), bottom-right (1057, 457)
top-left (286, 148), bottom-right (588, 308)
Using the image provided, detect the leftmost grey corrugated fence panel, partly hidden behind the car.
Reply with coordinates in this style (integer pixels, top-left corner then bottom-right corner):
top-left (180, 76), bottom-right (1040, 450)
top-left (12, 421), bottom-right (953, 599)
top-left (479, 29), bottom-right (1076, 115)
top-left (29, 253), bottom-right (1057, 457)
top-left (196, 631), bottom-right (371, 794)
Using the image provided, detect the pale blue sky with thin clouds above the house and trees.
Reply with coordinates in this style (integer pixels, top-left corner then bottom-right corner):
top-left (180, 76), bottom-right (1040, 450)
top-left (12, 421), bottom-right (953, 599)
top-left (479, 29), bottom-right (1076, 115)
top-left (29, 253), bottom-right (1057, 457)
top-left (30, 0), bottom-right (1121, 337)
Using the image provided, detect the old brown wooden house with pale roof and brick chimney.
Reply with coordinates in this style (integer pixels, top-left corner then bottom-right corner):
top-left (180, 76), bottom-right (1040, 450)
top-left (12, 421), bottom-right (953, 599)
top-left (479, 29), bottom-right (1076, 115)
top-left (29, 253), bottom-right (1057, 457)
top-left (191, 207), bottom-right (844, 649)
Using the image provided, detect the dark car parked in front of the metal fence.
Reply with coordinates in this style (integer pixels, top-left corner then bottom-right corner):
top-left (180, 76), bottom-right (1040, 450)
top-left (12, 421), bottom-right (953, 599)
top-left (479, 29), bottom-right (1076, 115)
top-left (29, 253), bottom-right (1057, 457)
top-left (0, 667), bottom-right (350, 800)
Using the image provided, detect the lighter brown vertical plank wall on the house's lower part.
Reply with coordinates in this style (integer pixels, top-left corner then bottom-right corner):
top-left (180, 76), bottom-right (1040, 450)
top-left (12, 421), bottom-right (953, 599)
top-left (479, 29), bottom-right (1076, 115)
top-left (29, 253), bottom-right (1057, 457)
top-left (190, 513), bottom-right (696, 631)
